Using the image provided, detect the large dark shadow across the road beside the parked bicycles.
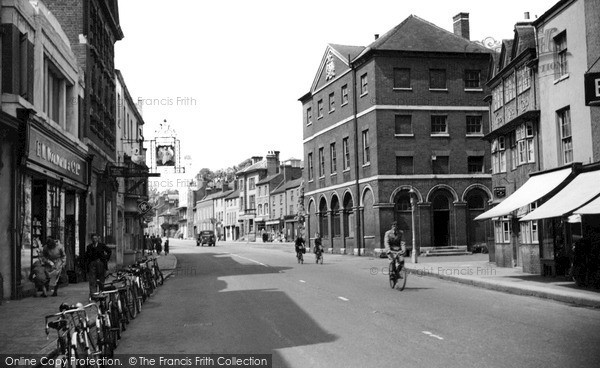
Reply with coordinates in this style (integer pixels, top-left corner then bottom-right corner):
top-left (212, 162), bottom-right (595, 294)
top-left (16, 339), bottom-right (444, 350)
top-left (119, 249), bottom-right (338, 367)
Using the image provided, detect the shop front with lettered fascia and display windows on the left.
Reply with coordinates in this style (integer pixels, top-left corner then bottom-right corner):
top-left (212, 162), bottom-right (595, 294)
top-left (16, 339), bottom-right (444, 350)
top-left (19, 123), bottom-right (89, 296)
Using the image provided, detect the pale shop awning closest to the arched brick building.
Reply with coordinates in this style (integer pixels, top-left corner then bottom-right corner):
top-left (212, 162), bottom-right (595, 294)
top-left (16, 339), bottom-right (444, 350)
top-left (475, 168), bottom-right (571, 220)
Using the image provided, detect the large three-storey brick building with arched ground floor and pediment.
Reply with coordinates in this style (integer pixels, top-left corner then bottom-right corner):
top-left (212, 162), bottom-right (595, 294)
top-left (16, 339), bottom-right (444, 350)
top-left (300, 13), bottom-right (492, 253)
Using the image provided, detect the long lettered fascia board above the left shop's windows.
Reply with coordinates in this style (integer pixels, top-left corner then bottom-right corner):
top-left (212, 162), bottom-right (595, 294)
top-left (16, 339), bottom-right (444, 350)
top-left (28, 126), bottom-right (87, 184)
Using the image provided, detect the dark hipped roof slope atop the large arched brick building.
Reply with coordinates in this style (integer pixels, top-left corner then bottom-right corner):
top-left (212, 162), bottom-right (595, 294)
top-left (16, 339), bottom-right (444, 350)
top-left (357, 15), bottom-right (491, 59)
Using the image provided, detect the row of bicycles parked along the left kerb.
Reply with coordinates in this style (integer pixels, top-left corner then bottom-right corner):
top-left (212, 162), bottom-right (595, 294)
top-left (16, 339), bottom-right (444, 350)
top-left (45, 257), bottom-right (164, 368)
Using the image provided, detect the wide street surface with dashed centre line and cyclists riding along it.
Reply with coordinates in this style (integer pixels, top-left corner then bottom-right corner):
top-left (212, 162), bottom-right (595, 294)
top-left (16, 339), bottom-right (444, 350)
top-left (116, 240), bottom-right (600, 367)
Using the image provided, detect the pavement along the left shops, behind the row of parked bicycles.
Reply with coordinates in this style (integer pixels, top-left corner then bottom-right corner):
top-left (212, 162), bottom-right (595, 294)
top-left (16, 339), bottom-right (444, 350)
top-left (0, 254), bottom-right (177, 356)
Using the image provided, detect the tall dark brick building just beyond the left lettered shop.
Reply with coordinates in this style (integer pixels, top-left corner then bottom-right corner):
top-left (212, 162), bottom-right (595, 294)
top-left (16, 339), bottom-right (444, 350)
top-left (44, 0), bottom-right (123, 247)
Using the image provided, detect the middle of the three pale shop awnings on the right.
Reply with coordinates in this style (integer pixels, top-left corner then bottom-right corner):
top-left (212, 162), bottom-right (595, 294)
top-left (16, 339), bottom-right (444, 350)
top-left (521, 170), bottom-right (600, 221)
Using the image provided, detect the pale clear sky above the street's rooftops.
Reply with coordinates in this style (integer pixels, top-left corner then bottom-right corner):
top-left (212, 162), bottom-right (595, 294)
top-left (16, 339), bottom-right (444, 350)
top-left (115, 0), bottom-right (557, 172)
